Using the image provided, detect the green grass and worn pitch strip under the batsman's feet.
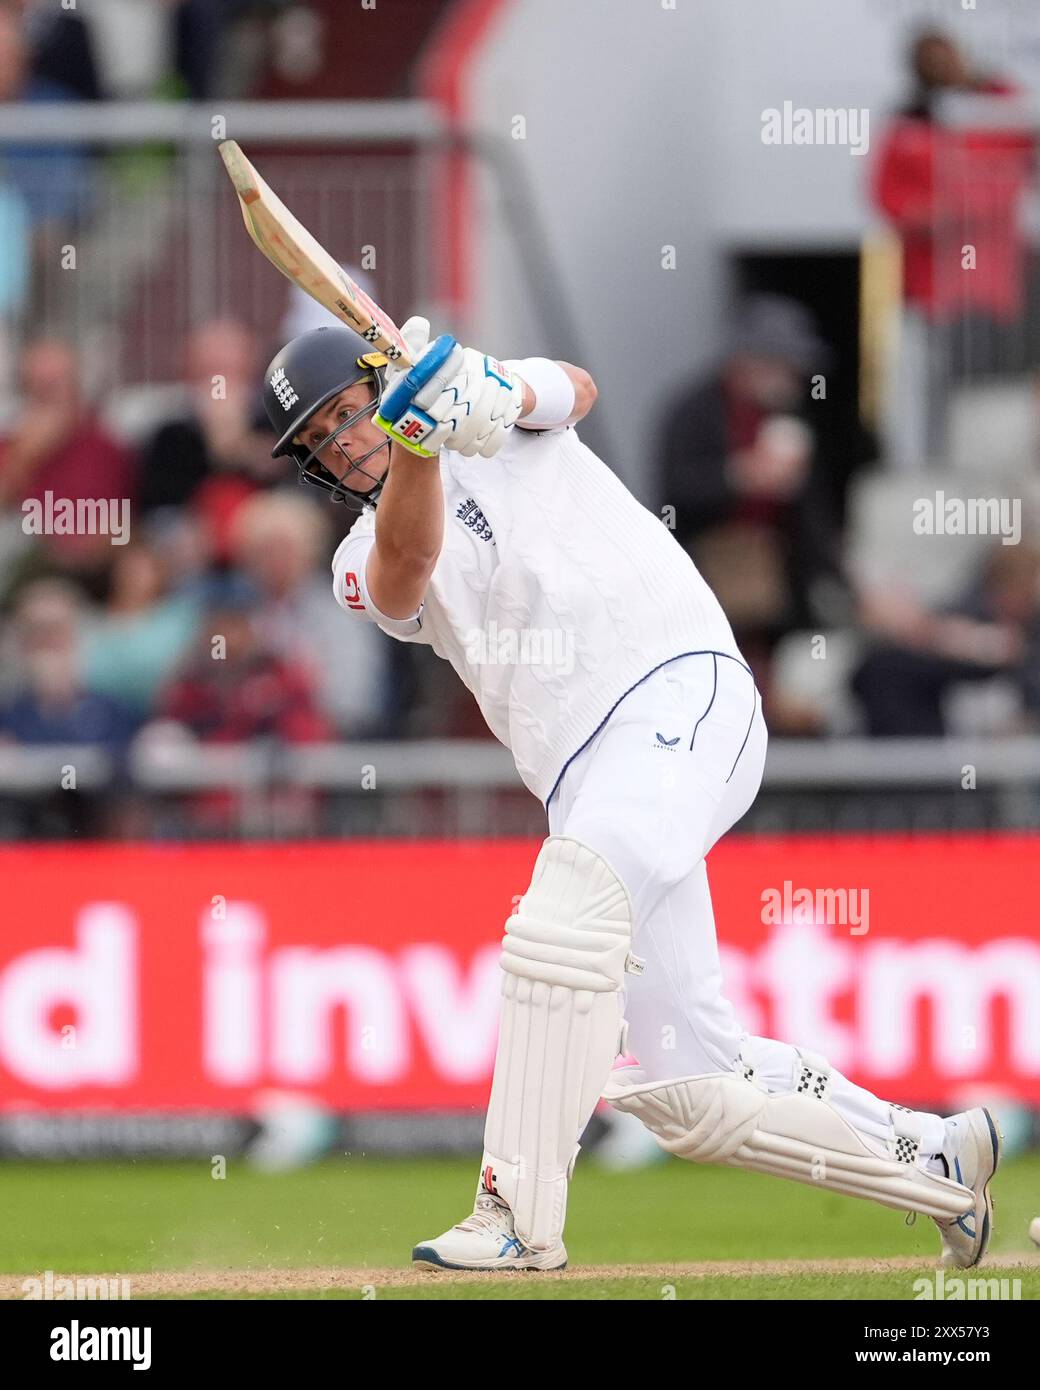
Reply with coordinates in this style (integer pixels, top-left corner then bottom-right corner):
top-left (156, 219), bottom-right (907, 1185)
top-left (0, 1154), bottom-right (1040, 1300)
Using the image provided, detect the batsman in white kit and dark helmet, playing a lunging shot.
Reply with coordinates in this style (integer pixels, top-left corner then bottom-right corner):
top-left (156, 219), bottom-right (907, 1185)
top-left (264, 318), bottom-right (1001, 1269)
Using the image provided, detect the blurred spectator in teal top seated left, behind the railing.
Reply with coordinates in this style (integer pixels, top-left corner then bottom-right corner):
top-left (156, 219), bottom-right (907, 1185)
top-left (83, 542), bottom-right (202, 717)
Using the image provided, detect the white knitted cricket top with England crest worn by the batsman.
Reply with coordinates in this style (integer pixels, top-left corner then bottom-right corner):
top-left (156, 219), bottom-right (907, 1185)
top-left (332, 427), bottom-right (742, 801)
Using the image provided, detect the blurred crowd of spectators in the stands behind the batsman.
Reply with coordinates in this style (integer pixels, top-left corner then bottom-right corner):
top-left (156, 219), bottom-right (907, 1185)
top-left (0, 0), bottom-right (1040, 838)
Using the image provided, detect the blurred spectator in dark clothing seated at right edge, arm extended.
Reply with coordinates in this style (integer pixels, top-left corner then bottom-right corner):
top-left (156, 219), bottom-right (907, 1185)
top-left (852, 545), bottom-right (1040, 738)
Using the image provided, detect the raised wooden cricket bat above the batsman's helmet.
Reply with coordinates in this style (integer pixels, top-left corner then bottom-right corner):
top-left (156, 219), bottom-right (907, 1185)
top-left (220, 140), bottom-right (414, 367)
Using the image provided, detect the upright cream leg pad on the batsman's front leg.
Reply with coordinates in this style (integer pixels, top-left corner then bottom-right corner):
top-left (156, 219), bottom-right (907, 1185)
top-left (481, 835), bottom-right (640, 1250)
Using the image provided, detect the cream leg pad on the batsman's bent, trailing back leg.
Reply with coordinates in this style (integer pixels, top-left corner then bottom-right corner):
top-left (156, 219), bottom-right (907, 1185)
top-left (603, 1051), bottom-right (975, 1220)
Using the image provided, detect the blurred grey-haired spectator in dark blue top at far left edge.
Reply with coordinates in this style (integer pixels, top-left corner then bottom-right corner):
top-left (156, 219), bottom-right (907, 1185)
top-left (0, 580), bottom-right (138, 755)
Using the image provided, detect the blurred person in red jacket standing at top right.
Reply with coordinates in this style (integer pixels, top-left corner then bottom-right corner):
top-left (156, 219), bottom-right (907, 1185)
top-left (873, 29), bottom-right (1033, 464)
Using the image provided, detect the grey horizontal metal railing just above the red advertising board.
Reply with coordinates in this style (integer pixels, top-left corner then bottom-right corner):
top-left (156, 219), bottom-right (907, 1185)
top-left (0, 737), bottom-right (1040, 838)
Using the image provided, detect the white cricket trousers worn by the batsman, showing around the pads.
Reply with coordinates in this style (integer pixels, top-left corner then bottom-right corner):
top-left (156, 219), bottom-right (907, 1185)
top-left (548, 652), bottom-right (944, 1158)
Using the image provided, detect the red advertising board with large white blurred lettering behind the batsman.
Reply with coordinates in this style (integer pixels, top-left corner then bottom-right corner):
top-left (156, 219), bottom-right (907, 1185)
top-left (0, 835), bottom-right (1040, 1111)
